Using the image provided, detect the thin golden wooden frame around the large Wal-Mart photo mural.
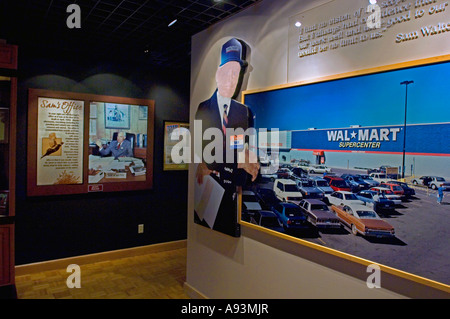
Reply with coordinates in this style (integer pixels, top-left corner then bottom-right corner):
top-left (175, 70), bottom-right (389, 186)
top-left (238, 55), bottom-right (450, 293)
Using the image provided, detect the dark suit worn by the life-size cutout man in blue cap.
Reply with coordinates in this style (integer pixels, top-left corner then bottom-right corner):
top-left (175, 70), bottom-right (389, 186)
top-left (195, 91), bottom-right (253, 236)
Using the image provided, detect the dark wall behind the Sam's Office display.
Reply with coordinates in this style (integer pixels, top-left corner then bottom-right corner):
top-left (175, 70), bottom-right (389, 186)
top-left (11, 47), bottom-right (189, 265)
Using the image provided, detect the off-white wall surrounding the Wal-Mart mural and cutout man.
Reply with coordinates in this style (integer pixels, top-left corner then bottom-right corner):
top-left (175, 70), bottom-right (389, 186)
top-left (186, 0), bottom-right (450, 298)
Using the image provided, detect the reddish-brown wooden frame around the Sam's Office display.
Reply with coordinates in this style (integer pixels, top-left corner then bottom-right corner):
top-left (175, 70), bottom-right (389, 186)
top-left (27, 89), bottom-right (154, 196)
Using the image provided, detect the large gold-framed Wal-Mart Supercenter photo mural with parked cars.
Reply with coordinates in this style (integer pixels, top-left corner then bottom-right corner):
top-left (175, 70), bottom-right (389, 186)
top-left (239, 55), bottom-right (450, 292)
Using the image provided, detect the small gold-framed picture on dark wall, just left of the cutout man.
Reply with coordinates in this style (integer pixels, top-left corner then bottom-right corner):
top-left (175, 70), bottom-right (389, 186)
top-left (163, 121), bottom-right (190, 171)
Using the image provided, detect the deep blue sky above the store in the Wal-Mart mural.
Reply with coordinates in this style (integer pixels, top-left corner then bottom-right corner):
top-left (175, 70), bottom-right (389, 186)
top-left (245, 62), bottom-right (450, 130)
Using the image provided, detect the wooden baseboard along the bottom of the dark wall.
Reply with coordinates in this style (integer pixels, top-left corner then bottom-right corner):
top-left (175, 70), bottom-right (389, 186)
top-left (15, 240), bottom-right (187, 276)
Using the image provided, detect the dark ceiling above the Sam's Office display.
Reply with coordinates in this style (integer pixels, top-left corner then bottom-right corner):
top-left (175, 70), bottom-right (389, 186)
top-left (0, 0), bottom-right (261, 68)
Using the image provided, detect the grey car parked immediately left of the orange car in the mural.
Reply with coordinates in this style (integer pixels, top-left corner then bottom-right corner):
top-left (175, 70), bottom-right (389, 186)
top-left (299, 199), bottom-right (341, 228)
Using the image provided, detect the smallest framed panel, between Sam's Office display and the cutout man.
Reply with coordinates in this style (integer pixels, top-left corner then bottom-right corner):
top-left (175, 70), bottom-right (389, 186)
top-left (163, 121), bottom-right (189, 171)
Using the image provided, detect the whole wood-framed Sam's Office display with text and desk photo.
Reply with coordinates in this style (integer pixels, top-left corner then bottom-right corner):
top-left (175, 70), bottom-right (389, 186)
top-left (27, 89), bottom-right (154, 196)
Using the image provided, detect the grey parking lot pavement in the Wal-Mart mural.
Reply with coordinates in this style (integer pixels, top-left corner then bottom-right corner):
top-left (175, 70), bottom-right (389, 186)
top-left (248, 169), bottom-right (450, 284)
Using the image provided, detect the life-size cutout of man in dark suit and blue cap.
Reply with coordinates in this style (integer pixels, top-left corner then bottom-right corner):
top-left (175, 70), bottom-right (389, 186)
top-left (195, 38), bottom-right (259, 237)
